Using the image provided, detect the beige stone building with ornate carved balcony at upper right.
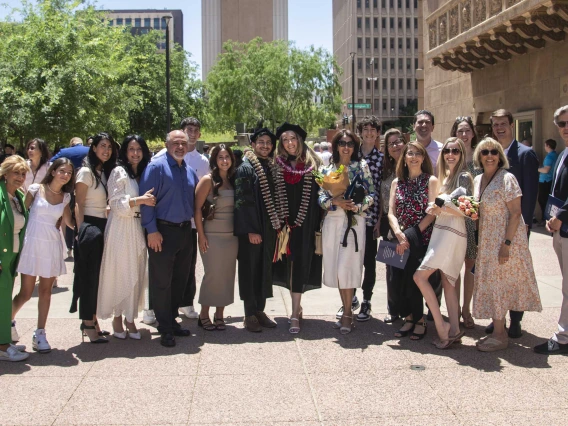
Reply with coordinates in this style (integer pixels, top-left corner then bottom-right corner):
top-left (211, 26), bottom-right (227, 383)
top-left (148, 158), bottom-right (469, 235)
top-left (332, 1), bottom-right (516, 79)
top-left (423, 0), bottom-right (568, 159)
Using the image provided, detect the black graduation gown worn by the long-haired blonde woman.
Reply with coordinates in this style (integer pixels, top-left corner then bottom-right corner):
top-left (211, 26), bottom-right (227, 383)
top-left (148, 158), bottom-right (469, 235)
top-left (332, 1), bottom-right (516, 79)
top-left (273, 176), bottom-right (323, 293)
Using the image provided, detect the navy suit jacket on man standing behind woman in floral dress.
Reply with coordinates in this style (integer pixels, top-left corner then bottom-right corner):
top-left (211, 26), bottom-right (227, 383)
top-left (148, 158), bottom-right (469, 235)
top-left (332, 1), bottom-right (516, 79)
top-left (507, 139), bottom-right (538, 228)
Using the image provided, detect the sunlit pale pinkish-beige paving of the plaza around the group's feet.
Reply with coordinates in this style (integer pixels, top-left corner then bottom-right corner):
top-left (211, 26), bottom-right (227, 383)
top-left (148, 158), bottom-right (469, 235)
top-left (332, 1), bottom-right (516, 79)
top-left (0, 228), bottom-right (568, 426)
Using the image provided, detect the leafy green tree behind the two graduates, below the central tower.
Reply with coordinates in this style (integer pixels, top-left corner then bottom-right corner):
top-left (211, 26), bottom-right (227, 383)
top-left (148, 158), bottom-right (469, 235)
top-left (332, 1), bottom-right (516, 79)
top-left (206, 38), bottom-right (341, 135)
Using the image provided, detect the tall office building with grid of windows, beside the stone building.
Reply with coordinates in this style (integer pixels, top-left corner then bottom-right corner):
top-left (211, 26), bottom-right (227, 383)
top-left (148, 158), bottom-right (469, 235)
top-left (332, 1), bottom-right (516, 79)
top-left (333, 0), bottom-right (420, 125)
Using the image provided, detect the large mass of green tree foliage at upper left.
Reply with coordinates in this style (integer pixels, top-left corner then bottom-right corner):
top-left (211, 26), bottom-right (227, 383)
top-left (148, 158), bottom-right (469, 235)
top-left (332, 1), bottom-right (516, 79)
top-left (0, 0), bottom-right (203, 144)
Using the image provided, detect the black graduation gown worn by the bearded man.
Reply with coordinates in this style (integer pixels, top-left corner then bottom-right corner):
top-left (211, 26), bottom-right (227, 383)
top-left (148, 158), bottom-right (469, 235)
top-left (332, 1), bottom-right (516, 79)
top-left (233, 158), bottom-right (276, 300)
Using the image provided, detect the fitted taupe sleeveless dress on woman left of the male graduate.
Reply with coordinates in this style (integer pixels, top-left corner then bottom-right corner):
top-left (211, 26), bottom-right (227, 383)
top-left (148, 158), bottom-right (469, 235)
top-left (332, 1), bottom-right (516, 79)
top-left (199, 189), bottom-right (239, 307)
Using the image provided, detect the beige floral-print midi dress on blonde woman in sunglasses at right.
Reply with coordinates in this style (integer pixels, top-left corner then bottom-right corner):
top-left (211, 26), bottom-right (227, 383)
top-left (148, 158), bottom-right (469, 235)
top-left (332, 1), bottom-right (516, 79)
top-left (473, 169), bottom-right (542, 319)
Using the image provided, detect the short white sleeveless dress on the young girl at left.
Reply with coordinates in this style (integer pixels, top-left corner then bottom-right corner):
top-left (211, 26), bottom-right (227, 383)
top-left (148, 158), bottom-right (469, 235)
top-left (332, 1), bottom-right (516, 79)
top-left (17, 183), bottom-right (71, 278)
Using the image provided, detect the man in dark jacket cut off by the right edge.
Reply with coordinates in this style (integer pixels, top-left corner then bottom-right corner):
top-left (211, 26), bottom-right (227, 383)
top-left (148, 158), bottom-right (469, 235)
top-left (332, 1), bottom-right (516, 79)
top-left (534, 105), bottom-right (568, 355)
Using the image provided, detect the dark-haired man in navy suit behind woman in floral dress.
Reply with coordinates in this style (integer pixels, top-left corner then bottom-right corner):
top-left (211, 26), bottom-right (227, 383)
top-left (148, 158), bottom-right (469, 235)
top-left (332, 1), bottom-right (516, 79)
top-left (485, 109), bottom-right (538, 338)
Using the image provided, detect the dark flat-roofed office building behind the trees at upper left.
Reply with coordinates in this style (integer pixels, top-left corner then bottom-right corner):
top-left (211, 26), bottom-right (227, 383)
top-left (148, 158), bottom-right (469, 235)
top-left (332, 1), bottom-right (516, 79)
top-left (103, 9), bottom-right (183, 50)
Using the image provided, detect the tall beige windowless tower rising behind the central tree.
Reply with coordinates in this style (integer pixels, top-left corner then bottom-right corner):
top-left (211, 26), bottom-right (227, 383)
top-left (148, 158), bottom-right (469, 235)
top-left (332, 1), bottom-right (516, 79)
top-left (201, 0), bottom-right (288, 80)
